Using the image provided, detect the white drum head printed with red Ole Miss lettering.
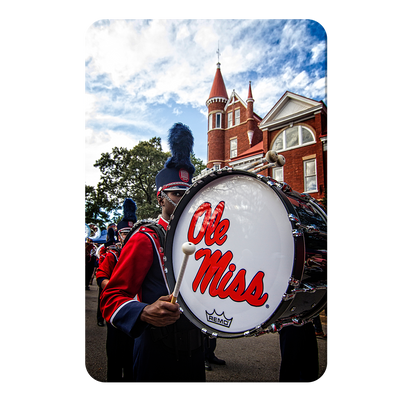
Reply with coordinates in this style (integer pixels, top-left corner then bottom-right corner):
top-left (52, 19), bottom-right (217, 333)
top-left (166, 174), bottom-right (295, 337)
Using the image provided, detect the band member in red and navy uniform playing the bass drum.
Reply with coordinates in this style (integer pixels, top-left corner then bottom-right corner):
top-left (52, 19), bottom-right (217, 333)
top-left (101, 123), bottom-right (205, 384)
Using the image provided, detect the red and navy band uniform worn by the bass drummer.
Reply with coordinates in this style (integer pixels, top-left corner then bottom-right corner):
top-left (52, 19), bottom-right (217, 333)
top-left (100, 218), bottom-right (205, 383)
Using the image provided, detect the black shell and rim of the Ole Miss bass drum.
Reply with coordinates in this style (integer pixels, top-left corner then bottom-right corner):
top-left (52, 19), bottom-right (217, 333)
top-left (165, 171), bottom-right (329, 338)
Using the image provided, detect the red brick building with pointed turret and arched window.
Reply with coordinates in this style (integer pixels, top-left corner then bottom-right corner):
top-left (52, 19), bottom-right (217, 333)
top-left (206, 63), bottom-right (330, 200)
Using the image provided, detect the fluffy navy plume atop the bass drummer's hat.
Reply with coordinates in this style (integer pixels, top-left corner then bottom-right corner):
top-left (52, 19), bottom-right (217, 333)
top-left (165, 122), bottom-right (195, 174)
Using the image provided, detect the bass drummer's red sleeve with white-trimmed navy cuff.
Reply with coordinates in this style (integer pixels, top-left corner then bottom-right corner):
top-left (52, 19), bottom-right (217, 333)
top-left (100, 231), bottom-right (153, 336)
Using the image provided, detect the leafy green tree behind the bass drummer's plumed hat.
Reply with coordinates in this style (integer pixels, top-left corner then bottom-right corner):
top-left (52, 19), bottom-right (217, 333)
top-left (94, 137), bottom-right (206, 220)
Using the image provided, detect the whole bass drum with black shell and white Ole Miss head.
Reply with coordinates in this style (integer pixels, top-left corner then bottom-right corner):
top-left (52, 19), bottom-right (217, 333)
top-left (164, 169), bottom-right (329, 338)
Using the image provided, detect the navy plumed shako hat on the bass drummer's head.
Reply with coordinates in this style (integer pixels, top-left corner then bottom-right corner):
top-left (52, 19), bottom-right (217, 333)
top-left (156, 122), bottom-right (195, 195)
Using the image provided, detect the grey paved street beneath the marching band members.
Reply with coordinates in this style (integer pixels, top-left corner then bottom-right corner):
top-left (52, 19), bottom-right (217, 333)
top-left (82, 280), bottom-right (330, 385)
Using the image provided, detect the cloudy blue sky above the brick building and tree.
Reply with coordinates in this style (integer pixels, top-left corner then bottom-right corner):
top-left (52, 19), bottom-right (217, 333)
top-left (82, 17), bottom-right (330, 186)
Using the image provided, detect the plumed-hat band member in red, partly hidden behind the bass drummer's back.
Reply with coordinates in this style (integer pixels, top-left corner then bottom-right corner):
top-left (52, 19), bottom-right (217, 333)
top-left (96, 198), bottom-right (137, 385)
